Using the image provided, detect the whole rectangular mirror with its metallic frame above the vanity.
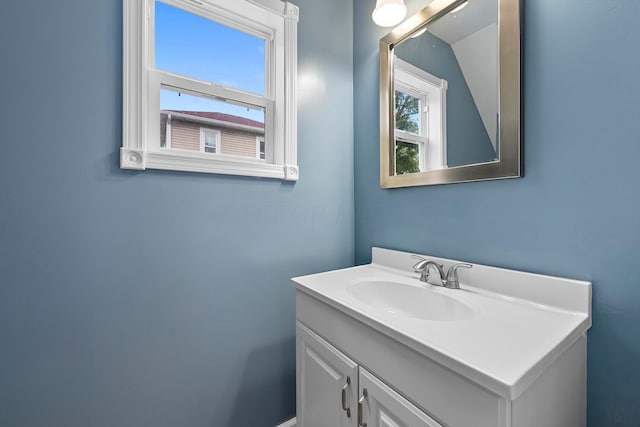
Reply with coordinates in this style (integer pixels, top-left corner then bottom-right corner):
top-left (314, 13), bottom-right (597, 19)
top-left (380, 0), bottom-right (522, 188)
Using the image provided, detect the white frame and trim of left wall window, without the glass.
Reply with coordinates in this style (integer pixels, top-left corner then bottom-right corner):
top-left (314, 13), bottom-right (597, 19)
top-left (120, 0), bottom-right (299, 181)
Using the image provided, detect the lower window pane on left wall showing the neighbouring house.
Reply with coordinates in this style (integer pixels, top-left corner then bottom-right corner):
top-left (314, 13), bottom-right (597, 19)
top-left (160, 89), bottom-right (264, 158)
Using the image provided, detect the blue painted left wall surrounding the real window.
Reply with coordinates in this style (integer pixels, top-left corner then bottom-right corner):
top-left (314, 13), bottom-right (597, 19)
top-left (0, 0), bottom-right (354, 427)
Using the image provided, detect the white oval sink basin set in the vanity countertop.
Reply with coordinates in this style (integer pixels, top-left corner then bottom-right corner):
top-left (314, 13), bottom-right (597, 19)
top-left (347, 281), bottom-right (474, 322)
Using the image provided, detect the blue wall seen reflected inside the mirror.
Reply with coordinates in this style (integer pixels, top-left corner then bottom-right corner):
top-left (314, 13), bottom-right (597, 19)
top-left (394, 31), bottom-right (496, 167)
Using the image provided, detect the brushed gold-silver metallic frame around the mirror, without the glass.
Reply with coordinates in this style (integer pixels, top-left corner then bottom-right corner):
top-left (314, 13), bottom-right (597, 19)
top-left (380, 0), bottom-right (523, 188)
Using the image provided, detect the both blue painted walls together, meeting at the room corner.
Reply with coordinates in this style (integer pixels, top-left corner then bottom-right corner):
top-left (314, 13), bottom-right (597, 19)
top-left (0, 0), bottom-right (640, 427)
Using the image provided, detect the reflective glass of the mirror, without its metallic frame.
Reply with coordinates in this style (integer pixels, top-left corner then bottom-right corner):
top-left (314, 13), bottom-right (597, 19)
top-left (393, 0), bottom-right (499, 175)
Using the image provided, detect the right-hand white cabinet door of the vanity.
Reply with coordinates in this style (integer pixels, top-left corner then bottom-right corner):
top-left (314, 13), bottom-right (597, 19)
top-left (356, 367), bottom-right (442, 427)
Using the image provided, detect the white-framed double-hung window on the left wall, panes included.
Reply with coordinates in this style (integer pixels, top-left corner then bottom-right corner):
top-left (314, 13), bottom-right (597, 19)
top-left (121, 0), bottom-right (298, 180)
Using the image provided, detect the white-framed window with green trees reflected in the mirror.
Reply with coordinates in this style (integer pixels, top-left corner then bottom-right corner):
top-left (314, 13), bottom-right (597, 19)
top-left (394, 58), bottom-right (447, 175)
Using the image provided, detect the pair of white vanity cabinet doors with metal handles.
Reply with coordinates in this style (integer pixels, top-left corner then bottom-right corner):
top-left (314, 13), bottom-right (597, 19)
top-left (296, 323), bottom-right (442, 427)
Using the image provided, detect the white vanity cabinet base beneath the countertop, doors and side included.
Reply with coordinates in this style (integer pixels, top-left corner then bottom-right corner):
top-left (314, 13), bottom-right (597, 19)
top-left (296, 292), bottom-right (586, 427)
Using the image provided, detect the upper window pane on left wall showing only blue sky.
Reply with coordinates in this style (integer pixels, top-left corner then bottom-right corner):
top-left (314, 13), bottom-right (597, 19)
top-left (155, 1), bottom-right (265, 95)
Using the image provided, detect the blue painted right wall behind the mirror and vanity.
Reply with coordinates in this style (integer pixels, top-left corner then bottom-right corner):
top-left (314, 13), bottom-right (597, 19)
top-left (354, 0), bottom-right (640, 427)
